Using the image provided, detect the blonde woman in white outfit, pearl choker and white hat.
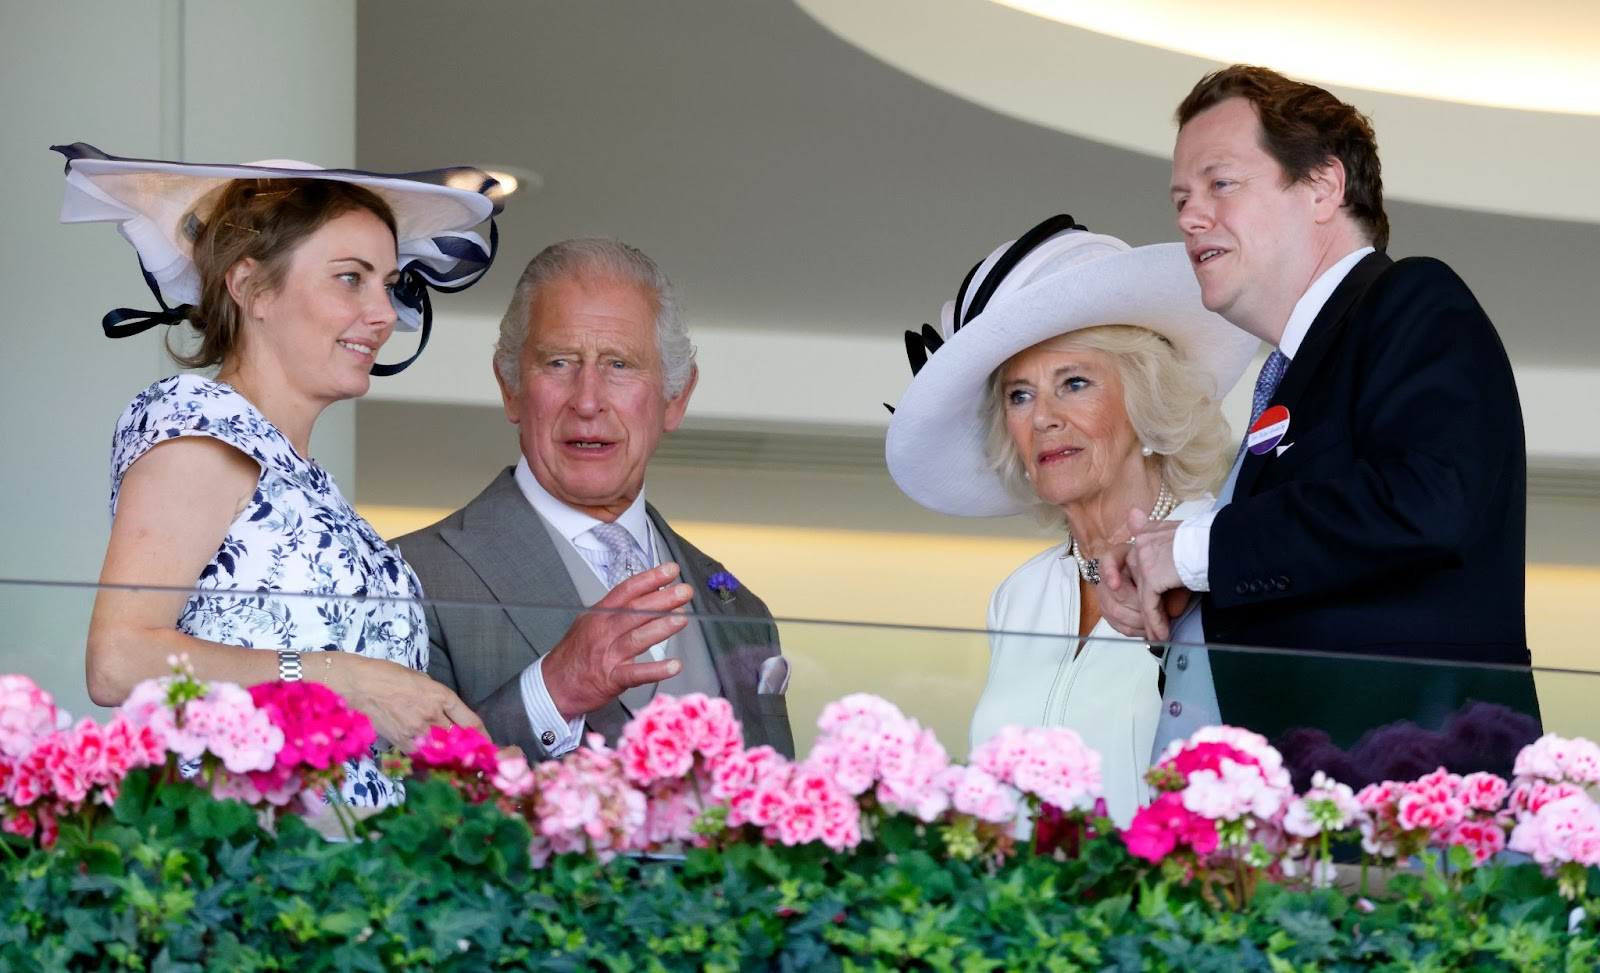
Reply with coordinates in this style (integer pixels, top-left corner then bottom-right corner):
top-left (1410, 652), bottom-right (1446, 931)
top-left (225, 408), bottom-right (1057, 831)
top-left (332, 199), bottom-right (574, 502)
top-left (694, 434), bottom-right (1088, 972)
top-left (886, 216), bottom-right (1256, 824)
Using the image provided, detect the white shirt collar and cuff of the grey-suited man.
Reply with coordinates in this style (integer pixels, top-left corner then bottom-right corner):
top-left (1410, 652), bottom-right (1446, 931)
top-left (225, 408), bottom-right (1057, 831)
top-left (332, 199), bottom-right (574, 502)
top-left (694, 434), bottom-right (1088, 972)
top-left (514, 458), bottom-right (664, 757)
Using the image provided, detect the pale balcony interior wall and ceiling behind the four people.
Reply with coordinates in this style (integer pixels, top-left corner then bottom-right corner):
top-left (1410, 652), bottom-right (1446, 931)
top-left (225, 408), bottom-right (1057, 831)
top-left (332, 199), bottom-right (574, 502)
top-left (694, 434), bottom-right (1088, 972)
top-left (0, 0), bottom-right (1600, 736)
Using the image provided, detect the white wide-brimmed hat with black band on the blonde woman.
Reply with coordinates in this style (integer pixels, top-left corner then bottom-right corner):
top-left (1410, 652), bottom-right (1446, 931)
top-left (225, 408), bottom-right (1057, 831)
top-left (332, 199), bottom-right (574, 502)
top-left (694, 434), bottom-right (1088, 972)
top-left (885, 216), bottom-right (1258, 517)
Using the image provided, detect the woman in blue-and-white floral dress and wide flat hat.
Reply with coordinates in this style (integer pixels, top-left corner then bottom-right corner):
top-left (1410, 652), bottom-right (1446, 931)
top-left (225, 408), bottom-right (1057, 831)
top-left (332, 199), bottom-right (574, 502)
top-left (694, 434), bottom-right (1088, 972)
top-left (58, 144), bottom-right (499, 807)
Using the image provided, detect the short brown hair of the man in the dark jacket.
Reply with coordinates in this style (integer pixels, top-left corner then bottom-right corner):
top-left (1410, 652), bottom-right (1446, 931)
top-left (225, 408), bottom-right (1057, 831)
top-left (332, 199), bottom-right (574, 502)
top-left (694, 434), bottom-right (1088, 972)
top-left (1178, 64), bottom-right (1389, 250)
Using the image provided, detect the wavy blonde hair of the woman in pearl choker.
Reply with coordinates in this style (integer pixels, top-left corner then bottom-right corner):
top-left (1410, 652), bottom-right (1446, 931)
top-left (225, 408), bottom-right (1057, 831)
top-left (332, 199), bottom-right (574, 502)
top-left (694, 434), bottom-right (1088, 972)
top-left (979, 325), bottom-right (1234, 522)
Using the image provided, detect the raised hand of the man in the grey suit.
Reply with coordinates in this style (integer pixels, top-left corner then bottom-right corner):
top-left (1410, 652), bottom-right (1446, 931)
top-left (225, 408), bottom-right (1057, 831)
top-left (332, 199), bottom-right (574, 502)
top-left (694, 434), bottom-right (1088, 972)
top-left (542, 563), bottom-right (694, 720)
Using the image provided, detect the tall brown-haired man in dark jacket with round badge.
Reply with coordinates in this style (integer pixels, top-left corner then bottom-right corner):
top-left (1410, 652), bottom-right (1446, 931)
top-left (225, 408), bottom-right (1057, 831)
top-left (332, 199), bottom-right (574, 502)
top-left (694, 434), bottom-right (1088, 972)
top-left (1102, 66), bottom-right (1538, 776)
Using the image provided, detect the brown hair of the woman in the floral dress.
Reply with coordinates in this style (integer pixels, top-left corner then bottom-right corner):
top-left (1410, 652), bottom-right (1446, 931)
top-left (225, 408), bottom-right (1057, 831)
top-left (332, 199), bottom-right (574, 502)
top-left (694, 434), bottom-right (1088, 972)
top-left (176, 179), bottom-right (395, 368)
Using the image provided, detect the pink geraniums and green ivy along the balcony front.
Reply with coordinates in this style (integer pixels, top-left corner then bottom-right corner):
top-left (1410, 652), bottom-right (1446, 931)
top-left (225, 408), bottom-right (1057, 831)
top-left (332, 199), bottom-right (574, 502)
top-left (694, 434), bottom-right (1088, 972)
top-left (0, 677), bottom-right (1600, 973)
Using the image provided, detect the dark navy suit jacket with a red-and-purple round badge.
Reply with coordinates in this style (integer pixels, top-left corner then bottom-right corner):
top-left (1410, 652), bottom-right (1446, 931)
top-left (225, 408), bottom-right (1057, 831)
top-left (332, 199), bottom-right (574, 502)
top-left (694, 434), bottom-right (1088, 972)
top-left (1203, 253), bottom-right (1538, 771)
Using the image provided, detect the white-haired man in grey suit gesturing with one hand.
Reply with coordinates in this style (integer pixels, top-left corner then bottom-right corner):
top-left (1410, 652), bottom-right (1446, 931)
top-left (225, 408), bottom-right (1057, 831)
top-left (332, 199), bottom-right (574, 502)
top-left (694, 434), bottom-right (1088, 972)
top-left (395, 240), bottom-right (794, 760)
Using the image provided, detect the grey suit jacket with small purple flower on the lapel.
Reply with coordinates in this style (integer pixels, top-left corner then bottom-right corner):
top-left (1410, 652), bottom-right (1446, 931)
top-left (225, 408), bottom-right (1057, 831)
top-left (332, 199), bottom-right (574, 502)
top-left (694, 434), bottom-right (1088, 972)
top-left (394, 467), bottom-right (794, 760)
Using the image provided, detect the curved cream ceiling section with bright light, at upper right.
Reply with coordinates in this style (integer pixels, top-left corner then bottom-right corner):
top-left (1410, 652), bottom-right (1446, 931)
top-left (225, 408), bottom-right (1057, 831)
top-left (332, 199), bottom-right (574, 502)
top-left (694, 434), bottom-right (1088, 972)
top-left (797, 0), bottom-right (1600, 222)
